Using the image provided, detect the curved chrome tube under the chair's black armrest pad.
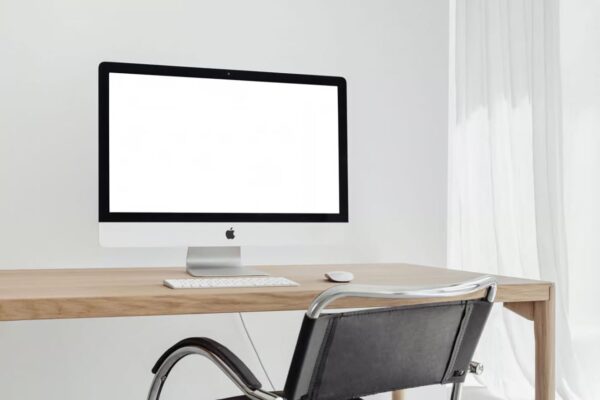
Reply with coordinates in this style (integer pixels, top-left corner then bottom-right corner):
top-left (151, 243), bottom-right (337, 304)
top-left (148, 346), bottom-right (281, 400)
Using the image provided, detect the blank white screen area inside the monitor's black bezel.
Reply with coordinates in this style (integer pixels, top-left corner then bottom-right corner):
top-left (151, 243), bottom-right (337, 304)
top-left (109, 73), bottom-right (340, 214)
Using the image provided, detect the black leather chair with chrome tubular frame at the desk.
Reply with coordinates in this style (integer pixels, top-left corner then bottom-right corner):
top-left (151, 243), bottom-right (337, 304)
top-left (148, 277), bottom-right (496, 400)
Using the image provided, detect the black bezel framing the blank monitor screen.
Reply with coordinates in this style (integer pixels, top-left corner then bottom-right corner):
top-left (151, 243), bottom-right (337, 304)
top-left (98, 62), bottom-right (348, 223)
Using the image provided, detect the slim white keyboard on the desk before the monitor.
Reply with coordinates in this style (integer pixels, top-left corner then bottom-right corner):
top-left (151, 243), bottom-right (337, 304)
top-left (163, 276), bottom-right (298, 289)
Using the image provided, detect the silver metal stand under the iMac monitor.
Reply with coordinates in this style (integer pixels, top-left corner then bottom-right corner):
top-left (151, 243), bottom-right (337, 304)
top-left (186, 246), bottom-right (268, 276)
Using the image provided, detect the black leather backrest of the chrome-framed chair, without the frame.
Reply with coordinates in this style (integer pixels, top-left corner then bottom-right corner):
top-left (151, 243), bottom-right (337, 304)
top-left (284, 300), bottom-right (492, 400)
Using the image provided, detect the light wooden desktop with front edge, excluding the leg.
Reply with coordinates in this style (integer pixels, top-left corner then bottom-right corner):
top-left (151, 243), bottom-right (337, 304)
top-left (0, 264), bottom-right (552, 321)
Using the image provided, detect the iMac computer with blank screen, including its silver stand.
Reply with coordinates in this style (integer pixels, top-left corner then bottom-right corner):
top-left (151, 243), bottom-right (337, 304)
top-left (99, 62), bottom-right (348, 276)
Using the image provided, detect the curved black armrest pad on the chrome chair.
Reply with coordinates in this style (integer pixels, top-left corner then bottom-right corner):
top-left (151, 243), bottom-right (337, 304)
top-left (152, 337), bottom-right (262, 390)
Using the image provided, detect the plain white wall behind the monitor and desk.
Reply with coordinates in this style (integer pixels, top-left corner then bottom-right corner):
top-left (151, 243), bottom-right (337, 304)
top-left (0, 0), bottom-right (448, 400)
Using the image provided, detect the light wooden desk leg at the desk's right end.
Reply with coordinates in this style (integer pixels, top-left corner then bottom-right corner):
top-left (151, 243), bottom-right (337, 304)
top-left (533, 286), bottom-right (556, 400)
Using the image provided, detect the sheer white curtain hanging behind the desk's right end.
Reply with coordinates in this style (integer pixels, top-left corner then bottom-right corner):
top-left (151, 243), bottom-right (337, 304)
top-left (448, 0), bottom-right (592, 400)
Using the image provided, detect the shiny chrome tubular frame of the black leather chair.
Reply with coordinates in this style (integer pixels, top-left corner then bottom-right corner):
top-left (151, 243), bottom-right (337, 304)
top-left (148, 276), bottom-right (497, 400)
